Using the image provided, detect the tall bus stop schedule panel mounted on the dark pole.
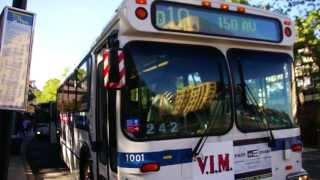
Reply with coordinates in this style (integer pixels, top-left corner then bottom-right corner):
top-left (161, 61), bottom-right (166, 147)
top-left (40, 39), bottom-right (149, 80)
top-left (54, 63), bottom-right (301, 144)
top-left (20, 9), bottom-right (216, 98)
top-left (0, 7), bottom-right (35, 110)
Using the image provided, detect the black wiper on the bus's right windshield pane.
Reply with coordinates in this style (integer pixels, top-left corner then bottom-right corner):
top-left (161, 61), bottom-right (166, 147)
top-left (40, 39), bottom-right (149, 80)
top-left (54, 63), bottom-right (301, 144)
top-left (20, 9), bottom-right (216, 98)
top-left (238, 61), bottom-right (275, 146)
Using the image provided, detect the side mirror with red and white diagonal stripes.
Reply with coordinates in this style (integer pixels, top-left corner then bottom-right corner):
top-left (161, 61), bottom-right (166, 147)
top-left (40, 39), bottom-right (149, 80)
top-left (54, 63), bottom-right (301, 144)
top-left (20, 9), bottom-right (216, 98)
top-left (103, 49), bottom-right (126, 89)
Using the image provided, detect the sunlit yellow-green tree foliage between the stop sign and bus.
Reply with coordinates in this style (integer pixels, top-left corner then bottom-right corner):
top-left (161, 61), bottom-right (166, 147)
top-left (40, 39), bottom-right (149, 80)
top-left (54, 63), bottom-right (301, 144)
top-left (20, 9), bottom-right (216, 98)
top-left (35, 79), bottom-right (60, 104)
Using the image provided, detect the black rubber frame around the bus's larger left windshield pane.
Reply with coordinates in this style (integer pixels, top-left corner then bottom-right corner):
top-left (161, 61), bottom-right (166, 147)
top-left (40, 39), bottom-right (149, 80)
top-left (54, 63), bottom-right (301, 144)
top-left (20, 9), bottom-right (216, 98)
top-left (120, 40), bottom-right (235, 142)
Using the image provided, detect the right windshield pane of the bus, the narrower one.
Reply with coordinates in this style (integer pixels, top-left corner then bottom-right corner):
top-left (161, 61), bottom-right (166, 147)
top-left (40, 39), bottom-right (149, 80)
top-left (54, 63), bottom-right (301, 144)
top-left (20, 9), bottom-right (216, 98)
top-left (228, 50), bottom-right (293, 132)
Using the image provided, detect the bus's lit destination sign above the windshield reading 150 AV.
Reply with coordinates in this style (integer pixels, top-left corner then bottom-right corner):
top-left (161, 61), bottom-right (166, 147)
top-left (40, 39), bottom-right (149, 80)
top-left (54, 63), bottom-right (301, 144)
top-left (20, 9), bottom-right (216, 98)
top-left (152, 2), bottom-right (282, 42)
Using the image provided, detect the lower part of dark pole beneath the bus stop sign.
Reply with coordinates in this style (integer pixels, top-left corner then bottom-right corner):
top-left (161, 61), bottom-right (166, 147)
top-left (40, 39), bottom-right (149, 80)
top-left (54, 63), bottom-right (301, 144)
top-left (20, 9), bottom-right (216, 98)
top-left (0, 110), bottom-right (15, 180)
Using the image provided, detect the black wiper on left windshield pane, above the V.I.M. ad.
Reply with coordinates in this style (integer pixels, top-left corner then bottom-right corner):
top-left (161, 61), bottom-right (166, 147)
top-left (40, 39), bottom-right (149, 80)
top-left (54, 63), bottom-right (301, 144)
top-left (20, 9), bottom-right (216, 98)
top-left (192, 95), bottom-right (226, 157)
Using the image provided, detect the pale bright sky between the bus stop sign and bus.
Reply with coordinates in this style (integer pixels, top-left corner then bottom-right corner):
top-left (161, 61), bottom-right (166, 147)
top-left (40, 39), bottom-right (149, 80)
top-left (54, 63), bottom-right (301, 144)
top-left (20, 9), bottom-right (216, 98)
top-left (0, 0), bottom-right (121, 89)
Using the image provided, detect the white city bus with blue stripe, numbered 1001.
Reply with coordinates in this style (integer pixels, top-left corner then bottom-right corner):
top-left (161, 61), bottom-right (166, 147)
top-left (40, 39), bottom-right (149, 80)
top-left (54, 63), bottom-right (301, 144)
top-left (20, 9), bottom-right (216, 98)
top-left (58, 0), bottom-right (308, 180)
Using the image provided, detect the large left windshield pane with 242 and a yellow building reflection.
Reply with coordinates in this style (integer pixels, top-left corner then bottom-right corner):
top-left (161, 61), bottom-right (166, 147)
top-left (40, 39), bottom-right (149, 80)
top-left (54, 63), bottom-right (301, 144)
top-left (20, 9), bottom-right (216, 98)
top-left (122, 42), bottom-right (232, 140)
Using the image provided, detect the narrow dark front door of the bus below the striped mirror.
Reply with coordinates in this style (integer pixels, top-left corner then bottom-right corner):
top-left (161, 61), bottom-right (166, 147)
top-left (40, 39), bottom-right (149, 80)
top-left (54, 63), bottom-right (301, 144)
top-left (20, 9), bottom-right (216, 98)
top-left (96, 55), bottom-right (117, 180)
